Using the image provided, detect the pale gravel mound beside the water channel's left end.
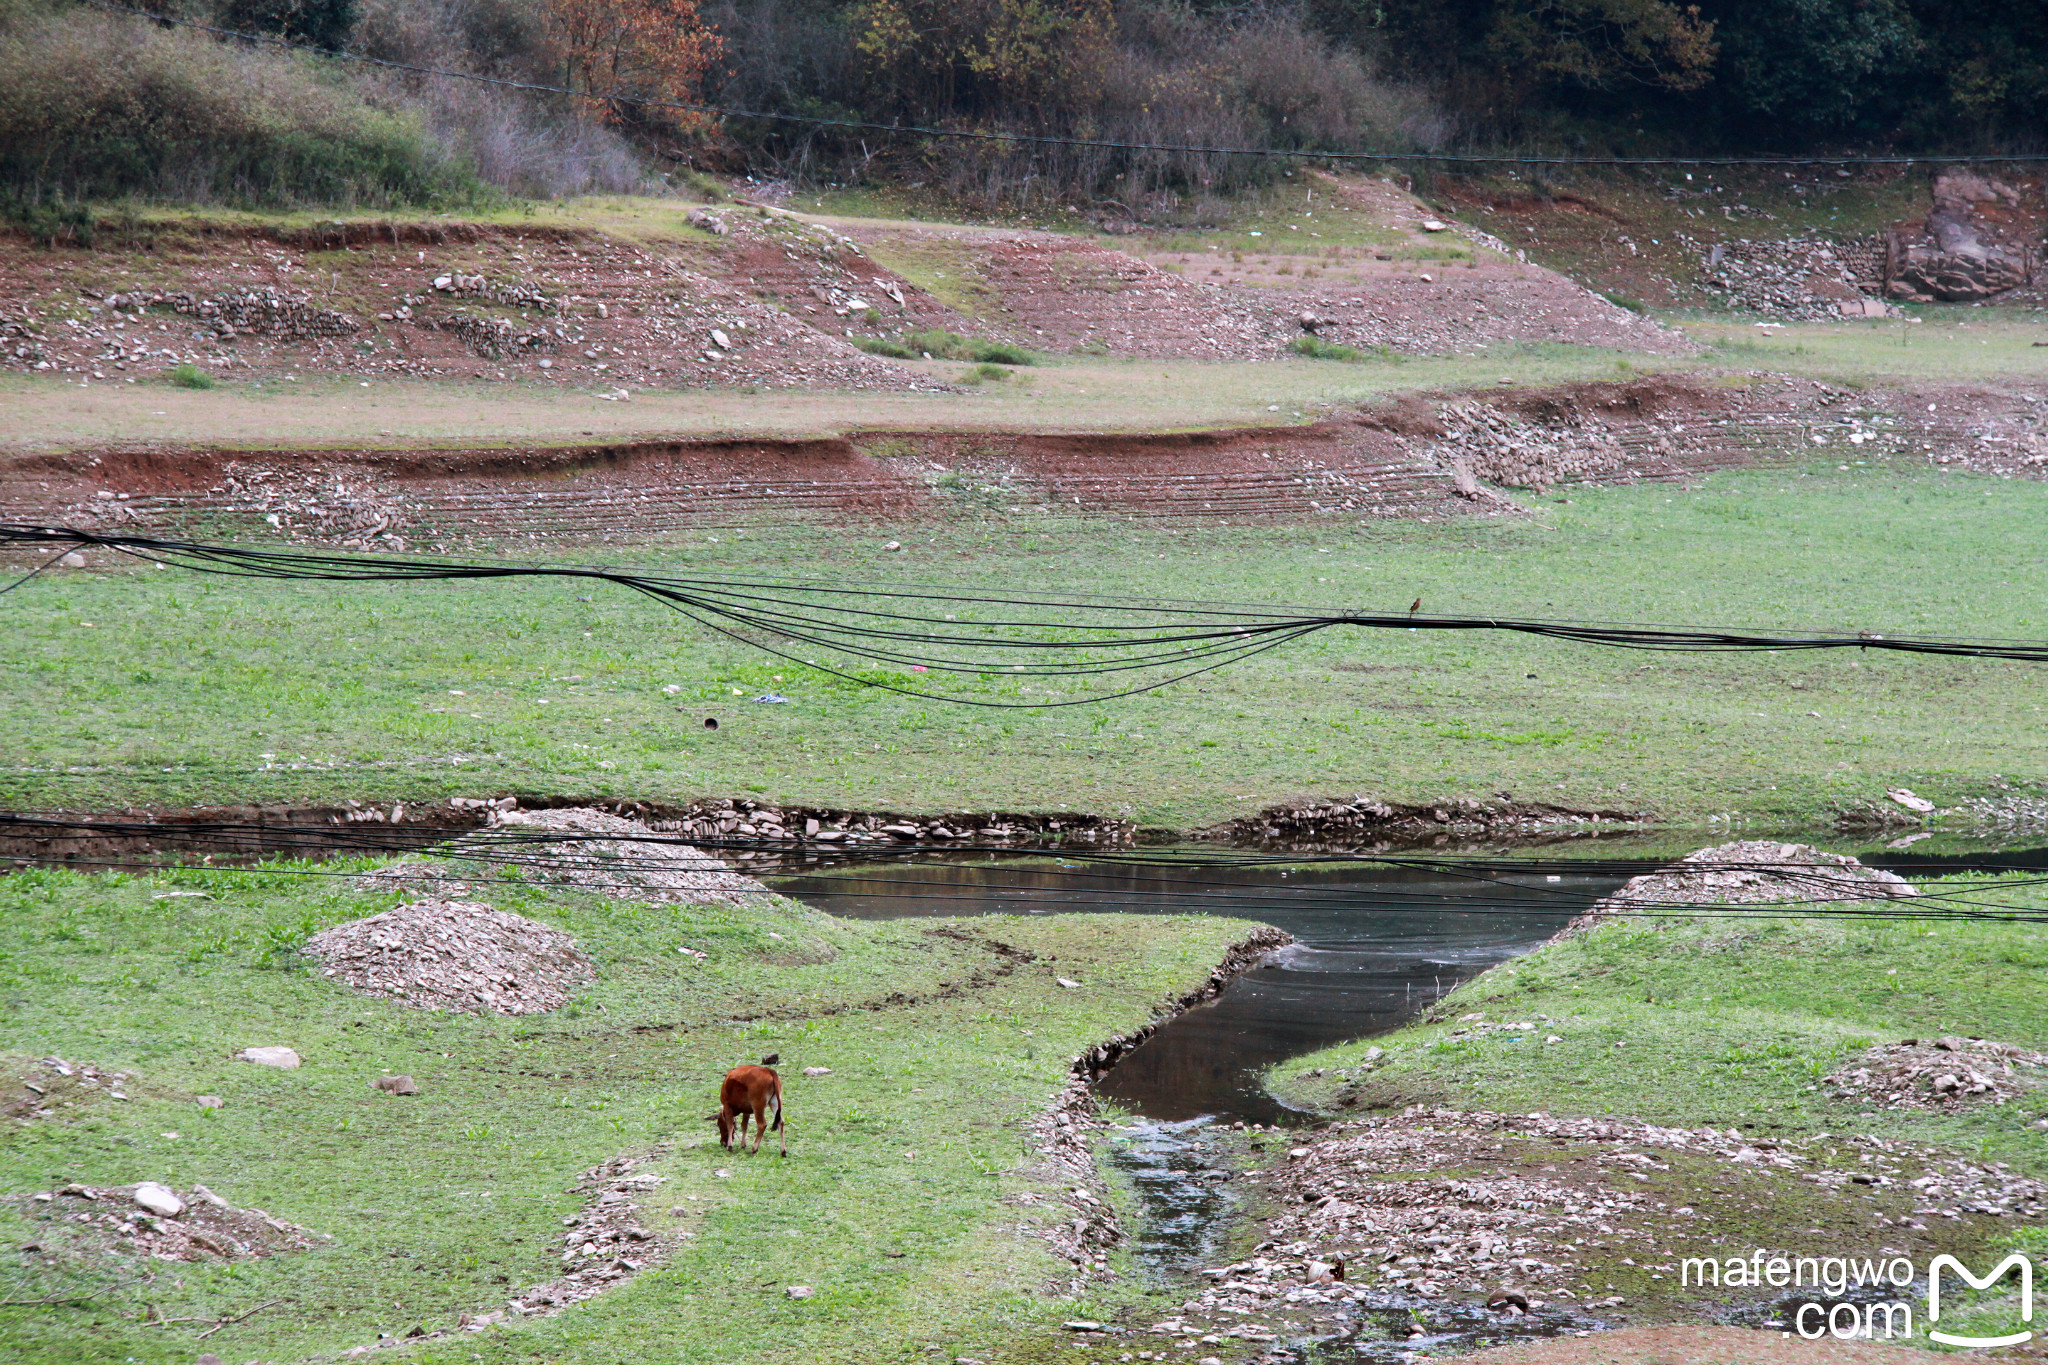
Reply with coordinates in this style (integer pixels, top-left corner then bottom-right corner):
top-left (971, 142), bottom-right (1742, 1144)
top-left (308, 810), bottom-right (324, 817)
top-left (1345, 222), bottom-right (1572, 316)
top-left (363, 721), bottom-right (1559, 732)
top-left (468, 806), bottom-right (768, 905)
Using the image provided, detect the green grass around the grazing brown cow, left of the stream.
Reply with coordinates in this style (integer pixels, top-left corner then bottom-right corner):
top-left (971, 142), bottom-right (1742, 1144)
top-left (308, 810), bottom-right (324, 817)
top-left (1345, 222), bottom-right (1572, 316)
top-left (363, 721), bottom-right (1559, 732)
top-left (0, 864), bottom-right (1245, 1365)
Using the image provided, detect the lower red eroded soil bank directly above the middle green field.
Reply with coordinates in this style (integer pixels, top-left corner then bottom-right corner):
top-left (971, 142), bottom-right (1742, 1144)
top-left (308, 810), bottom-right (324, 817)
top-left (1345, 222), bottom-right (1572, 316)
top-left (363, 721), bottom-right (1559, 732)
top-left (0, 375), bottom-right (2048, 548)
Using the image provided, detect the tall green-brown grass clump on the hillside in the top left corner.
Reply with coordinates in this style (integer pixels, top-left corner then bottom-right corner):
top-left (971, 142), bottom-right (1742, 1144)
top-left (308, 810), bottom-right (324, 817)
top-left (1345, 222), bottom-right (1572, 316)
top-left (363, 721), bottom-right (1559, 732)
top-left (0, 4), bottom-right (487, 207)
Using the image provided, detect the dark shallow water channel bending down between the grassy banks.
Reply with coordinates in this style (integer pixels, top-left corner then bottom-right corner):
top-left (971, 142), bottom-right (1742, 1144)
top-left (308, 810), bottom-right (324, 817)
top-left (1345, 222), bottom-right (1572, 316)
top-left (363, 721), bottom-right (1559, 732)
top-left (770, 855), bottom-right (1624, 1273)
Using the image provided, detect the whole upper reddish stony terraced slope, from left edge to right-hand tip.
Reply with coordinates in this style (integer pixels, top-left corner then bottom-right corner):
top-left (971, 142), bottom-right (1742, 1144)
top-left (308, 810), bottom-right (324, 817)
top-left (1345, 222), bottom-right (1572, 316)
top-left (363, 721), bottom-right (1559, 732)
top-left (0, 184), bottom-right (1692, 391)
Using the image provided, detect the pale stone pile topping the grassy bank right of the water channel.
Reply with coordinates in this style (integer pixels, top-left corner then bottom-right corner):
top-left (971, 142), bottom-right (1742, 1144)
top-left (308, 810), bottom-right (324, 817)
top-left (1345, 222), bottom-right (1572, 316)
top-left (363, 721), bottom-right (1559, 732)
top-left (1559, 839), bottom-right (1919, 937)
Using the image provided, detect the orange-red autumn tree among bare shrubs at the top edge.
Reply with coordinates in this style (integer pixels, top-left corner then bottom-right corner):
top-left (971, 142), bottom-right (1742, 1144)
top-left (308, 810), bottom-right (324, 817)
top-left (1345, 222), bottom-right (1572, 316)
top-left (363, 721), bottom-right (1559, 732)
top-left (545, 0), bottom-right (721, 131)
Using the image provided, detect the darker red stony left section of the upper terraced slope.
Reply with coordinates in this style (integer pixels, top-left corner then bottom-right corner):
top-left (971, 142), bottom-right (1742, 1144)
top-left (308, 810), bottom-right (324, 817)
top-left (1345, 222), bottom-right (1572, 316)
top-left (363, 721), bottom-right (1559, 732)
top-left (0, 215), bottom-right (942, 391)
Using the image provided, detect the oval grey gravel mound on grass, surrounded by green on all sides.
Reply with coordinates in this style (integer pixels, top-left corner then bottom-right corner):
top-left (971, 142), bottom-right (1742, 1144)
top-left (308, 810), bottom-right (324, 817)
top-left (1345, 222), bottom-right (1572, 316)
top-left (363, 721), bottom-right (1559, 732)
top-left (305, 900), bottom-right (596, 1015)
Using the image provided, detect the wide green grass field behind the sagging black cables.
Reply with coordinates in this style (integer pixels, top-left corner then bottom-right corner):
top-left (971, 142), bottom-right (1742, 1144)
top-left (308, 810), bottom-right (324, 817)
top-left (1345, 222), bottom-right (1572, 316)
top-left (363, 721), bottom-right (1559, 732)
top-left (0, 454), bottom-right (2048, 829)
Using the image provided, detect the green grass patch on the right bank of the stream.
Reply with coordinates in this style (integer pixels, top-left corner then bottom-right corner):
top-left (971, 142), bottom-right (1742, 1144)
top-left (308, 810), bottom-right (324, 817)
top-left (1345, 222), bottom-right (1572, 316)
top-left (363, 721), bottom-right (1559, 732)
top-left (1274, 878), bottom-right (2048, 1173)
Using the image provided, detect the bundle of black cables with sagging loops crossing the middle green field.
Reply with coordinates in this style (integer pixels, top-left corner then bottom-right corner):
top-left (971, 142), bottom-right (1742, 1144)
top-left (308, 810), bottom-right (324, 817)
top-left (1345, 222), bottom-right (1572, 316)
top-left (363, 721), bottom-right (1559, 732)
top-left (0, 524), bottom-right (2048, 710)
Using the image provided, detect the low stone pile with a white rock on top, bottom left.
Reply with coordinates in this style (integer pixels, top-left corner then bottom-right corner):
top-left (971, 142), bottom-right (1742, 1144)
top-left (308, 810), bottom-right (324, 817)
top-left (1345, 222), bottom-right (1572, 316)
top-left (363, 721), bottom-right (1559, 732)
top-left (0, 1181), bottom-right (326, 1265)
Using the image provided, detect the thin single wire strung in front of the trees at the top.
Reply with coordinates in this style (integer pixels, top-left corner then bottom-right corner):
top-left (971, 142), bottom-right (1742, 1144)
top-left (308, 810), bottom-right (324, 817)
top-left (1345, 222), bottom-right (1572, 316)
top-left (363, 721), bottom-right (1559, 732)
top-left (80, 0), bottom-right (2048, 166)
